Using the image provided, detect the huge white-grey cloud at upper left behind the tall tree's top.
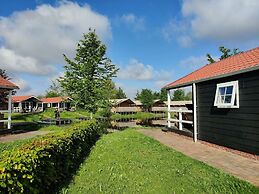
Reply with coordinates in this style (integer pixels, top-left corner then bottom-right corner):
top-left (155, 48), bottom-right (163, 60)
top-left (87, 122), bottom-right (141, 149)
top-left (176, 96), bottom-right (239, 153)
top-left (0, 1), bottom-right (111, 75)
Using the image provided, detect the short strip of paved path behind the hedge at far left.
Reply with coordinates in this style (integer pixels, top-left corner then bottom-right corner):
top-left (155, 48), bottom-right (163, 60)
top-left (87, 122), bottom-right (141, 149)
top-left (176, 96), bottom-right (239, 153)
top-left (0, 131), bottom-right (51, 143)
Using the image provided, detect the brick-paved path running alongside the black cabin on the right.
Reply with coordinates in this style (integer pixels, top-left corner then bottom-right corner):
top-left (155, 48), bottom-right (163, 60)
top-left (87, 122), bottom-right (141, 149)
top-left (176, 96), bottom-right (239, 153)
top-left (139, 129), bottom-right (259, 186)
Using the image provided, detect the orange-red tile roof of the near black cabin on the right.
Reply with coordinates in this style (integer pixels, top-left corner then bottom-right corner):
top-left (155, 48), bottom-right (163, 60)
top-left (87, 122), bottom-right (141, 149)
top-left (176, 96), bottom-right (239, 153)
top-left (165, 47), bottom-right (259, 89)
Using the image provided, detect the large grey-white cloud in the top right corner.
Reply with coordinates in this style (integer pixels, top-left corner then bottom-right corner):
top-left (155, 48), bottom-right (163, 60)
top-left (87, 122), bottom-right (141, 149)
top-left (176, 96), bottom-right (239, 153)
top-left (162, 0), bottom-right (259, 44)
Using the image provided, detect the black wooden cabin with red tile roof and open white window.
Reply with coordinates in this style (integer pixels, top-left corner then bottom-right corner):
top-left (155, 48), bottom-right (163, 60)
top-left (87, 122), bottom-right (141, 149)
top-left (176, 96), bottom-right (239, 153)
top-left (166, 47), bottom-right (259, 155)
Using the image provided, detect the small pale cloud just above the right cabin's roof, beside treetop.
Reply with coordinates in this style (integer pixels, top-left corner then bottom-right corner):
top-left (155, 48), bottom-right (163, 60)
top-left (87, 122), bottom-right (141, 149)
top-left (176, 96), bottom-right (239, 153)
top-left (180, 56), bottom-right (208, 70)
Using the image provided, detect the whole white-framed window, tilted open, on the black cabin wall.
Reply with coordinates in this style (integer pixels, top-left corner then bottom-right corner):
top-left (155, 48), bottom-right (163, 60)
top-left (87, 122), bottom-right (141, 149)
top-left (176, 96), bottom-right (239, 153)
top-left (214, 81), bottom-right (239, 108)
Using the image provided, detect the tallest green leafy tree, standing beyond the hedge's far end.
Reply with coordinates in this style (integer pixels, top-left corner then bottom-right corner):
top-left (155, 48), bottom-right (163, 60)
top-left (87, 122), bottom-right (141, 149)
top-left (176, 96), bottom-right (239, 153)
top-left (59, 29), bottom-right (118, 113)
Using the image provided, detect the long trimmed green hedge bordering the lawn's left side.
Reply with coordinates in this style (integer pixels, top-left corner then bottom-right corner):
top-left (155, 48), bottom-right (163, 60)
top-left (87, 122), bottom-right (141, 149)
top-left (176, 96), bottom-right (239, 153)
top-left (0, 121), bottom-right (104, 193)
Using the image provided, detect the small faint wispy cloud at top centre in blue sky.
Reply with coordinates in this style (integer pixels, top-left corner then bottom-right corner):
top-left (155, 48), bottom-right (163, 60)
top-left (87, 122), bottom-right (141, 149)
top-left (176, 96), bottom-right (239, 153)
top-left (120, 13), bottom-right (145, 31)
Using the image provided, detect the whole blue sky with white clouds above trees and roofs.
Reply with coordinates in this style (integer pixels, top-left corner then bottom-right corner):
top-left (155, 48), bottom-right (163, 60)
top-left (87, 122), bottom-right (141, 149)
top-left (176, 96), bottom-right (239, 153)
top-left (0, 0), bottom-right (259, 97)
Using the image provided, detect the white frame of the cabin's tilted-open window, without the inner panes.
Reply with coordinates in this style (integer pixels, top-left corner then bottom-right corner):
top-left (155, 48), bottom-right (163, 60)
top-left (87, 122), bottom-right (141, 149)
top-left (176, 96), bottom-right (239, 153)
top-left (214, 81), bottom-right (239, 108)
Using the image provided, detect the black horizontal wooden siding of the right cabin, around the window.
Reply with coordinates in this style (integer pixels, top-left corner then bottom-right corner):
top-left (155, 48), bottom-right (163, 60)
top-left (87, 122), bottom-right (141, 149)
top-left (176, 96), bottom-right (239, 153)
top-left (197, 71), bottom-right (259, 154)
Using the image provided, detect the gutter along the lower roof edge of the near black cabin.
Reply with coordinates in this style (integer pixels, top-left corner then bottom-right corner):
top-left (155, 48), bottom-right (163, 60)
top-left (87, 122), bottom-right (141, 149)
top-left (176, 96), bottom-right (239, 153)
top-left (164, 64), bottom-right (259, 90)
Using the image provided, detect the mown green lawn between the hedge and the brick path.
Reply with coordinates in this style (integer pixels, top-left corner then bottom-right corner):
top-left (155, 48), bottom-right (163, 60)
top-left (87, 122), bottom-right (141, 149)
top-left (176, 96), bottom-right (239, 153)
top-left (64, 130), bottom-right (259, 194)
